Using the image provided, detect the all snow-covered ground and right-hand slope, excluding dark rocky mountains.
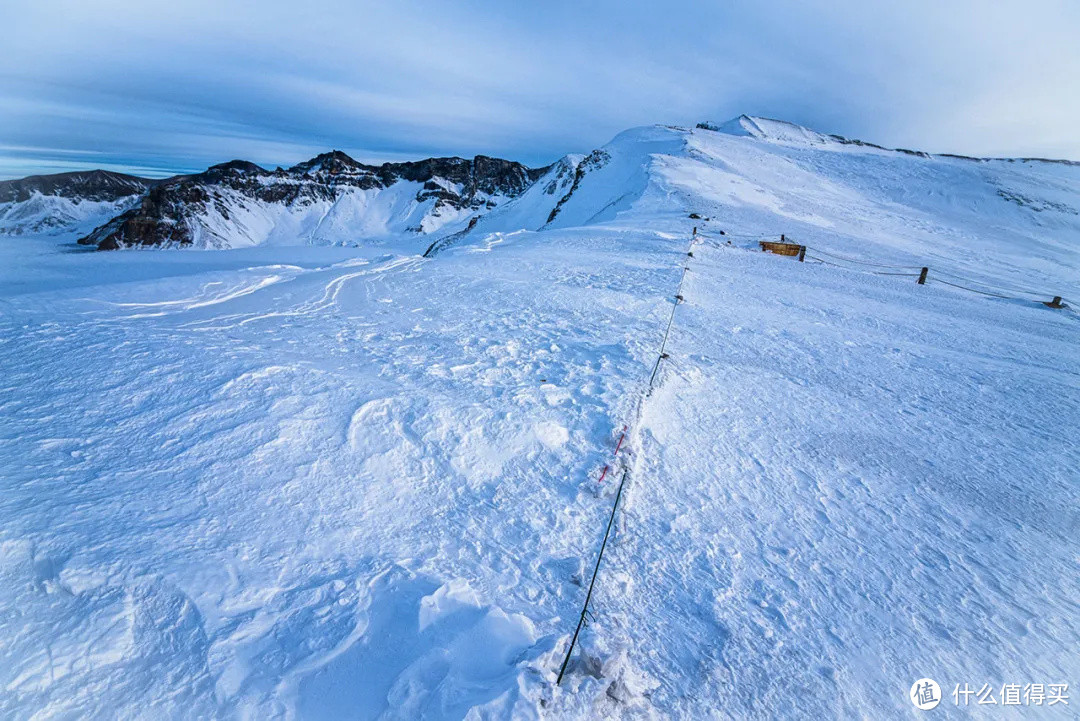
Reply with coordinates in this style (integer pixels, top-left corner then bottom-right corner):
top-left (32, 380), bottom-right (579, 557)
top-left (0, 120), bottom-right (1080, 719)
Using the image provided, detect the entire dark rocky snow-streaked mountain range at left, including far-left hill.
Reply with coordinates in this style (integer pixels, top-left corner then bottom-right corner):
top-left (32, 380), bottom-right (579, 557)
top-left (0, 150), bottom-right (549, 249)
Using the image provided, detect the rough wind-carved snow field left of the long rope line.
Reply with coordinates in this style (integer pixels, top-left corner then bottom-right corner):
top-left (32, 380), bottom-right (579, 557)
top-left (0, 227), bottom-right (699, 718)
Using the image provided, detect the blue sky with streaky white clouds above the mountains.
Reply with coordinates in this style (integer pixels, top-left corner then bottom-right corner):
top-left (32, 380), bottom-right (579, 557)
top-left (0, 0), bottom-right (1080, 178)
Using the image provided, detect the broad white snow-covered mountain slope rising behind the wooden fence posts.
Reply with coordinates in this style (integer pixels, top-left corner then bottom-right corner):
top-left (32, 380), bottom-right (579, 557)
top-left (454, 117), bottom-right (1080, 297)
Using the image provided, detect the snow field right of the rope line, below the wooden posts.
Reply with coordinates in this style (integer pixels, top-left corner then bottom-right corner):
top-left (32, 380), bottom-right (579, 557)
top-left (561, 239), bottom-right (1080, 718)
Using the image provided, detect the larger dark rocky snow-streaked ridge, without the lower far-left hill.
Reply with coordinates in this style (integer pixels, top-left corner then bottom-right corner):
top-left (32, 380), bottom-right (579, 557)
top-left (79, 151), bottom-right (546, 249)
